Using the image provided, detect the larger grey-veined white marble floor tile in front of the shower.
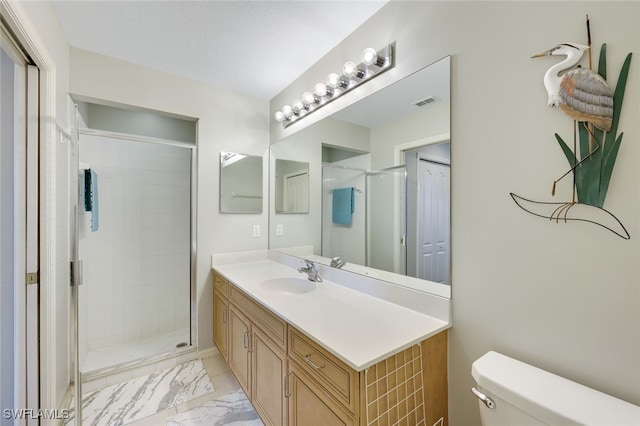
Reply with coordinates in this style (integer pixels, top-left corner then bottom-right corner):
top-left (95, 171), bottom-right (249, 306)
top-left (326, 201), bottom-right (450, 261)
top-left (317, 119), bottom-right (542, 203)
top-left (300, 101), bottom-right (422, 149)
top-left (68, 360), bottom-right (214, 426)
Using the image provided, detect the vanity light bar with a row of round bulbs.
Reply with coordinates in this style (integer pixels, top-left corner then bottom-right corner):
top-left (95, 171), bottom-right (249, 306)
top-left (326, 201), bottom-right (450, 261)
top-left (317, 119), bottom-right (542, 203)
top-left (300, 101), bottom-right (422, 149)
top-left (274, 44), bottom-right (395, 128)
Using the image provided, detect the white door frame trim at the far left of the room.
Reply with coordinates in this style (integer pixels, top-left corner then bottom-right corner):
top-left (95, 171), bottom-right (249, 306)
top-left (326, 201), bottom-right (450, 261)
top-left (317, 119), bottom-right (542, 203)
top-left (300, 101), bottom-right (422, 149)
top-left (0, 0), bottom-right (66, 409)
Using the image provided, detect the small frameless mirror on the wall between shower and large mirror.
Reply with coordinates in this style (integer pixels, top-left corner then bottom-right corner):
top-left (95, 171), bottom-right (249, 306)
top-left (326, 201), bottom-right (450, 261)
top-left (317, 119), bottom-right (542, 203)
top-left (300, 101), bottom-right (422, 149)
top-left (220, 152), bottom-right (262, 213)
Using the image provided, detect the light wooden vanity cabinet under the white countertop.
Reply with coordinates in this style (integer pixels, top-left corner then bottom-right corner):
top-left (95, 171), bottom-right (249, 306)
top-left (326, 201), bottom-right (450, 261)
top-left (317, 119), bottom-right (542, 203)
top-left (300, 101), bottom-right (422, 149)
top-left (214, 274), bottom-right (448, 426)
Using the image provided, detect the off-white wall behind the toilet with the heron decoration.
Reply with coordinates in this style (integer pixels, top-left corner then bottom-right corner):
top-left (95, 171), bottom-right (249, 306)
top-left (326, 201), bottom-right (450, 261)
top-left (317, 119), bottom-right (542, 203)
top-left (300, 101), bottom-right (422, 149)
top-left (271, 1), bottom-right (640, 426)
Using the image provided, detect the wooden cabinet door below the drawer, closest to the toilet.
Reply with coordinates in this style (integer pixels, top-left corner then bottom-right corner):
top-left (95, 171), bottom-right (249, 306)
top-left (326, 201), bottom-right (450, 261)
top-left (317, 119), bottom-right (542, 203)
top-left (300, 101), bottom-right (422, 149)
top-left (287, 364), bottom-right (356, 426)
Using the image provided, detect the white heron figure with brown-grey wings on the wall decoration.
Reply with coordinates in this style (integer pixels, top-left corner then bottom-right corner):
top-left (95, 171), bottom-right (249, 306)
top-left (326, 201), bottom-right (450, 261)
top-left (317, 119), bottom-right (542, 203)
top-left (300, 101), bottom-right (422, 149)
top-left (532, 43), bottom-right (613, 131)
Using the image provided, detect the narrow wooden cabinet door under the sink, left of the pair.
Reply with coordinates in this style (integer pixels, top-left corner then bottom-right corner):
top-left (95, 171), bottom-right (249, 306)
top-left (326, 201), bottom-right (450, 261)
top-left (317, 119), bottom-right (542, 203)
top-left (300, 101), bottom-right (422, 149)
top-left (228, 304), bottom-right (251, 395)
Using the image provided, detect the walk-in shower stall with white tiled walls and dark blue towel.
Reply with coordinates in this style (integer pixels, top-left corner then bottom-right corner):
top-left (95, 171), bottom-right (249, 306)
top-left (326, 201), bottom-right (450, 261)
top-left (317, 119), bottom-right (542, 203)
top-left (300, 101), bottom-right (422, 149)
top-left (76, 102), bottom-right (196, 383)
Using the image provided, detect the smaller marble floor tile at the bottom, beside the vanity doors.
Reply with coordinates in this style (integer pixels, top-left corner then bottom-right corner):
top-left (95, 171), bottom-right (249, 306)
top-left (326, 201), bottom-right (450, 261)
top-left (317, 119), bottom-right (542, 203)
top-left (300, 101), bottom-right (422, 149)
top-left (166, 390), bottom-right (263, 426)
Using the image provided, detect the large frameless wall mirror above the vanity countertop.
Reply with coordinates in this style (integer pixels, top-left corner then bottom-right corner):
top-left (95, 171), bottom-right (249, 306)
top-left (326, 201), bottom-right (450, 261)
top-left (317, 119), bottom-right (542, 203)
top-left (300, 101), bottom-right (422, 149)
top-left (269, 57), bottom-right (451, 297)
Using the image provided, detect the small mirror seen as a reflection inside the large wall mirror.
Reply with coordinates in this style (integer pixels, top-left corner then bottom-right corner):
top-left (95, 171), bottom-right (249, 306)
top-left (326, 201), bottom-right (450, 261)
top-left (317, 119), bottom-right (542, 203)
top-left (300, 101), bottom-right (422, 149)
top-left (274, 158), bottom-right (309, 213)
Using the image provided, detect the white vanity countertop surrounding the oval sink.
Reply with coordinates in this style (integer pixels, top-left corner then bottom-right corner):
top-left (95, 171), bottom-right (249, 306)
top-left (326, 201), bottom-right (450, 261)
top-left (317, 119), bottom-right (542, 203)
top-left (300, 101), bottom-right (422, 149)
top-left (215, 260), bottom-right (450, 371)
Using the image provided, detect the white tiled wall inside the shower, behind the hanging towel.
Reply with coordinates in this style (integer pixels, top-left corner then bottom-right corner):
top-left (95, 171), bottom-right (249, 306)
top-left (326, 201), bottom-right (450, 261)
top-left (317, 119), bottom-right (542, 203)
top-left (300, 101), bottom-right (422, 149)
top-left (79, 135), bottom-right (191, 364)
